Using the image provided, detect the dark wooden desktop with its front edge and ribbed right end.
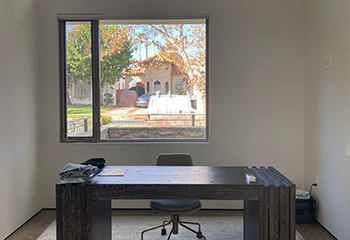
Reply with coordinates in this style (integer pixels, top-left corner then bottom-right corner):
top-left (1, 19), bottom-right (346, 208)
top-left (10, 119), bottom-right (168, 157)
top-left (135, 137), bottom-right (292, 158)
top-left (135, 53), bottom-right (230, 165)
top-left (56, 166), bottom-right (295, 200)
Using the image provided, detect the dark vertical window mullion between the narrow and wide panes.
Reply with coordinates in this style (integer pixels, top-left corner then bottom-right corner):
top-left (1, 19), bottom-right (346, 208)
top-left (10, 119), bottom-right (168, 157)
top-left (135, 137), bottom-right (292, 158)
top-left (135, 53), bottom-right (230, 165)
top-left (91, 20), bottom-right (101, 141)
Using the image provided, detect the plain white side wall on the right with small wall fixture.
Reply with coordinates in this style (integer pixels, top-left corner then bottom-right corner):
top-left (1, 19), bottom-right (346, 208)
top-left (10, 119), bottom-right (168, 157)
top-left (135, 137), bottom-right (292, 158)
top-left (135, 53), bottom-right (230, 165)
top-left (305, 0), bottom-right (350, 240)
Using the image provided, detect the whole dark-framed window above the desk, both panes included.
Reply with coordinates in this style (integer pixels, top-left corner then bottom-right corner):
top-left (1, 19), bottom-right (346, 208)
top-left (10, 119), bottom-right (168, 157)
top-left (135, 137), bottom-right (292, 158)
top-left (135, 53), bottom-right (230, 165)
top-left (58, 14), bottom-right (208, 142)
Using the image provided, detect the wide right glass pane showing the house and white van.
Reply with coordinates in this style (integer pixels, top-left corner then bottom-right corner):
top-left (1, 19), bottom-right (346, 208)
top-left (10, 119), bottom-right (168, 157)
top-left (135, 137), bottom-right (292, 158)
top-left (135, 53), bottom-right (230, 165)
top-left (100, 19), bottom-right (206, 141)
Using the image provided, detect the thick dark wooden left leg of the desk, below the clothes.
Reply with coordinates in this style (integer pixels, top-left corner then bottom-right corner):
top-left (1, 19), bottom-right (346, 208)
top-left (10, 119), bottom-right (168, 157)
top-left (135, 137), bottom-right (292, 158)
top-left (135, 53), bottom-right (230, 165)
top-left (56, 184), bottom-right (112, 240)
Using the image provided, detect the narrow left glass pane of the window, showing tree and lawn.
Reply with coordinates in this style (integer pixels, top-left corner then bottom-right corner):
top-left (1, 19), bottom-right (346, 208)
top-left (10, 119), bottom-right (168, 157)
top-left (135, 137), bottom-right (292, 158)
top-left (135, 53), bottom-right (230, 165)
top-left (66, 22), bottom-right (93, 137)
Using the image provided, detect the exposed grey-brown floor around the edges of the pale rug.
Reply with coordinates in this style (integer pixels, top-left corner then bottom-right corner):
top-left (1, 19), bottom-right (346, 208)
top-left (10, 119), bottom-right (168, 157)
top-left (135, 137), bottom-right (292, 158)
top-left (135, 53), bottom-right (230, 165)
top-left (7, 210), bottom-right (336, 240)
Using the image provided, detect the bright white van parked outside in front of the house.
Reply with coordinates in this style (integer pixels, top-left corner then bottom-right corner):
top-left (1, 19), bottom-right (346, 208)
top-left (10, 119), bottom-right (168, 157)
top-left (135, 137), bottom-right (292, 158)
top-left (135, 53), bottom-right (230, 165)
top-left (147, 94), bottom-right (197, 115)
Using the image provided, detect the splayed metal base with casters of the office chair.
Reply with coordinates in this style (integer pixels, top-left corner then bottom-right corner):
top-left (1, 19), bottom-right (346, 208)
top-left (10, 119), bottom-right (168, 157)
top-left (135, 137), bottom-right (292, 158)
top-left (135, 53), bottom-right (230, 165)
top-left (141, 215), bottom-right (206, 240)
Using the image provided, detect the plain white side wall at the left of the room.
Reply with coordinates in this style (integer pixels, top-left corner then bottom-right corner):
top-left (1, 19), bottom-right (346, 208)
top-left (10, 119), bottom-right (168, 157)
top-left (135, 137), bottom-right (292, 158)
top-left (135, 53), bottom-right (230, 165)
top-left (0, 0), bottom-right (42, 239)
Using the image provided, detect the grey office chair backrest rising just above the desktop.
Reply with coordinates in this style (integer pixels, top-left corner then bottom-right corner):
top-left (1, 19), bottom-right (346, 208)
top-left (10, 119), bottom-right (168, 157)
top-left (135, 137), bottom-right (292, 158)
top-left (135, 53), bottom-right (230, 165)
top-left (157, 153), bottom-right (193, 166)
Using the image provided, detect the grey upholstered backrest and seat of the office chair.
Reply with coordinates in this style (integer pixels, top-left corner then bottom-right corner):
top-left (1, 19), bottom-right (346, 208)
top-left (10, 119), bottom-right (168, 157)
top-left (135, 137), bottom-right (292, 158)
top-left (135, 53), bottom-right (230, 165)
top-left (150, 153), bottom-right (202, 215)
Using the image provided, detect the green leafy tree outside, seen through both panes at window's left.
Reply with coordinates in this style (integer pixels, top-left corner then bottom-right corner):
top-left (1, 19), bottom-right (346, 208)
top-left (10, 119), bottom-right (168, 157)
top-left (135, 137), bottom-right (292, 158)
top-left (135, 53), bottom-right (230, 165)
top-left (66, 25), bottom-right (132, 105)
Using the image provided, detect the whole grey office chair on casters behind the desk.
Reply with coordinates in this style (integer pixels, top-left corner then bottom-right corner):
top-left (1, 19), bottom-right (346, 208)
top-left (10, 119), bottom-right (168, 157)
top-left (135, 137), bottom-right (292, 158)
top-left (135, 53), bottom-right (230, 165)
top-left (141, 153), bottom-right (206, 240)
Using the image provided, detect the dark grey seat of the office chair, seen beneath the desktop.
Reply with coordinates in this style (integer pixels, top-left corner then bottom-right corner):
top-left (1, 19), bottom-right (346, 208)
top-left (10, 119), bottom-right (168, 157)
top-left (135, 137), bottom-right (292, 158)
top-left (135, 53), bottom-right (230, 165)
top-left (150, 200), bottom-right (201, 215)
